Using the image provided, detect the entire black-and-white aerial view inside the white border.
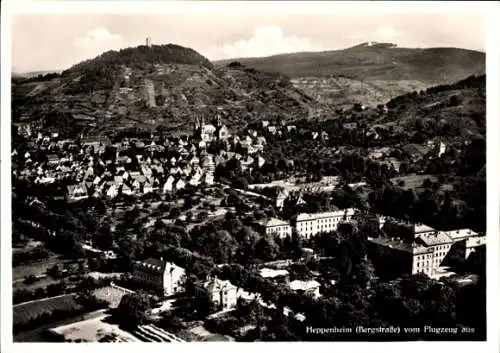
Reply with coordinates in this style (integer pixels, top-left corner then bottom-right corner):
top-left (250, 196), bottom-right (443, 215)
top-left (2, 2), bottom-right (487, 343)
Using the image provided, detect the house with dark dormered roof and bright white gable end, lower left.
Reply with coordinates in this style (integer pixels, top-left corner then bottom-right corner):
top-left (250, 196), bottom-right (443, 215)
top-left (132, 258), bottom-right (186, 296)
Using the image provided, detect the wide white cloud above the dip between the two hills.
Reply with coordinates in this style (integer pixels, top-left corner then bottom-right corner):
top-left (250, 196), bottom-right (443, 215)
top-left (209, 26), bottom-right (324, 60)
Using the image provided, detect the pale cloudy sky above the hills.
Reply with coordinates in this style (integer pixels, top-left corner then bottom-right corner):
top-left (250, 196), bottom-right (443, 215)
top-left (12, 11), bottom-right (485, 73)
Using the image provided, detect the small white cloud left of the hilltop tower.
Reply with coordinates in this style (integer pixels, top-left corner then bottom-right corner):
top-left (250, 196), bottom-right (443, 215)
top-left (73, 27), bottom-right (124, 60)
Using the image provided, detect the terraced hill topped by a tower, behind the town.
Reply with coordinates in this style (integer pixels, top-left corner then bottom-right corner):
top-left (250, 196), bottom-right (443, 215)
top-left (12, 44), bottom-right (321, 135)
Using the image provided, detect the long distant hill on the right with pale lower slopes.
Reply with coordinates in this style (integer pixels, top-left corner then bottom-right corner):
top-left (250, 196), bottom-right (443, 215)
top-left (215, 43), bottom-right (485, 106)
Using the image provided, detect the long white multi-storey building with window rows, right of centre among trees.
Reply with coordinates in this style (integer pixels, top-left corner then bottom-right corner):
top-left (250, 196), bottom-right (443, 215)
top-left (295, 208), bottom-right (355, 238)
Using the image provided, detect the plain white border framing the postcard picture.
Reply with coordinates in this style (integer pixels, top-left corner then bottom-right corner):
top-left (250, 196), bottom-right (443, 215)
top-left (0, 0), bottom-right (500, 353)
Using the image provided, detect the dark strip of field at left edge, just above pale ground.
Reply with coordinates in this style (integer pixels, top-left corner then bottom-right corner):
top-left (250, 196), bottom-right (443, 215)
top-left (12, 294), bottom-right (79, 325)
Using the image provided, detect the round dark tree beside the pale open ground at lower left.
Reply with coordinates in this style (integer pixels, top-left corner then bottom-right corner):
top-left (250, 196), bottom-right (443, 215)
top-left (116, 292), bottom-right (151, 328)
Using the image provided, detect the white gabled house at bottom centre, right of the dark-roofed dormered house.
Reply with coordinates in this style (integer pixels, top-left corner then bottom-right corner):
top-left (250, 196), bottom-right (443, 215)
top-left (195, 277), bottom-right (238, 311)
